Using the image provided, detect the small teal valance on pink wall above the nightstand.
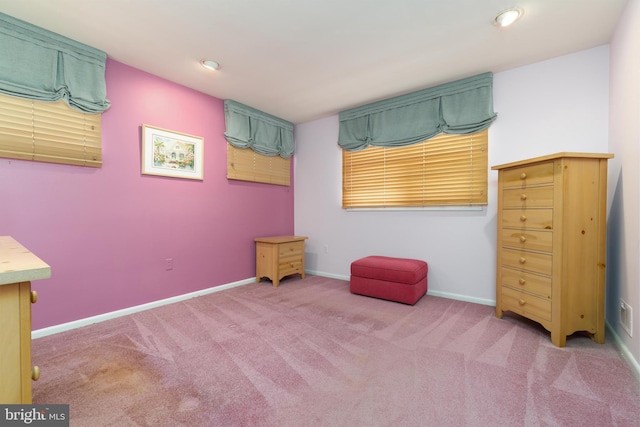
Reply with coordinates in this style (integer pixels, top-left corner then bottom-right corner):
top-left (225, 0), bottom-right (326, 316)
top-left (224, 99), bottom-right (294, 159)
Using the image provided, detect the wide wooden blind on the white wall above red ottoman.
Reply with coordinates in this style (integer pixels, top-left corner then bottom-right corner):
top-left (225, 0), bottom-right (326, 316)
top-left (342, 130), bottom-right (489, 208)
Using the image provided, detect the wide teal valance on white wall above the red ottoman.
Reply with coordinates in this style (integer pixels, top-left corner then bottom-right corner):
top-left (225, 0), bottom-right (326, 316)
top-left (338, 73), bottom-right (497, 151)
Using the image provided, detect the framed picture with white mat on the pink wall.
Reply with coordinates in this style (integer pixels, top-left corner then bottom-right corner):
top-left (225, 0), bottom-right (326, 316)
top-left (142, 124), bottom-right (204, 180)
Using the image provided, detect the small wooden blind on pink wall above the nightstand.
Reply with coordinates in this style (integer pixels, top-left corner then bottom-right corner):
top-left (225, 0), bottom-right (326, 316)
top-left (227, 143), bottom-right (291, 186)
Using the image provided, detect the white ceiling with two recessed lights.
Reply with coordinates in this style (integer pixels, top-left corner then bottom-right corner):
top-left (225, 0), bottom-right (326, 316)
top-left (0, 0), bottom-right (627, 123)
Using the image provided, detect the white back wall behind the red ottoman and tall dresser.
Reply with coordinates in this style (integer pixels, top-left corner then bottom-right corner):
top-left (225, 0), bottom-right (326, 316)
top-left (294, 46), bottom-right (608, 306)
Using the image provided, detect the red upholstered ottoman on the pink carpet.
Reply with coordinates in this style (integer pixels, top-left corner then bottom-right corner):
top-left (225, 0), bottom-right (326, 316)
top-left (349, 256), bottom-right (429, 305)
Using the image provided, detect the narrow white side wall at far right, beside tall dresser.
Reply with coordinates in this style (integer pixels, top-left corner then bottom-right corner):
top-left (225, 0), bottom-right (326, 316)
top-left (606, 0), bottom-right (640, 373)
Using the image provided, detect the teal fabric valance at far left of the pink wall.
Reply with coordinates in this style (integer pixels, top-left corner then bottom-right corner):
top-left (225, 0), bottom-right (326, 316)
top-left (0, 13), bottom-right (110, 113)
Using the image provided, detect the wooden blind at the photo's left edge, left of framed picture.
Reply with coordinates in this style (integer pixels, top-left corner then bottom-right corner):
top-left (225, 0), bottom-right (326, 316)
top-left (0, 94), bottom-right (102, 167)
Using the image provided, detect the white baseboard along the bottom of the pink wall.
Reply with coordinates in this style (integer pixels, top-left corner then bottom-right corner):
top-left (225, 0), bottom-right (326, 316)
top-left (31, 277), bottom-right (256, 339)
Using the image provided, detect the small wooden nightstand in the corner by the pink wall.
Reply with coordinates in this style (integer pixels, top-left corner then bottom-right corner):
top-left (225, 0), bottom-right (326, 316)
top-left (254, 236), bottom-right (307, 288)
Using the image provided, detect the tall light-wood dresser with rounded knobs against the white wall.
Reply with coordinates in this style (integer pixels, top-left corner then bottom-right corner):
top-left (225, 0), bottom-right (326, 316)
top-left (491, 153), bottom-right (613, 347)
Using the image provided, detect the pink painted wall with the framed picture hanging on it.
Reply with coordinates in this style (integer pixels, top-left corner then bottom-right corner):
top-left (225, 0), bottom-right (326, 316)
top-left (0, 60), bottom-right (294, 329)
